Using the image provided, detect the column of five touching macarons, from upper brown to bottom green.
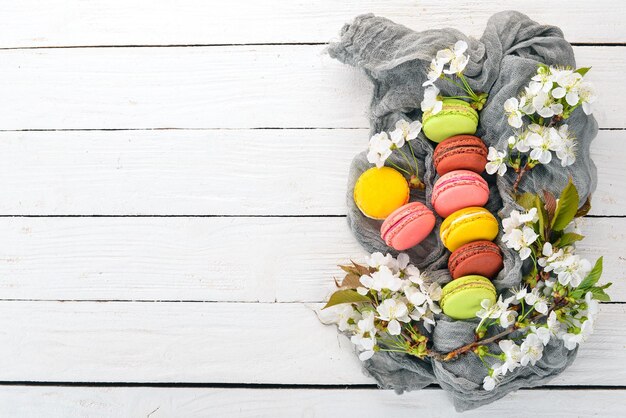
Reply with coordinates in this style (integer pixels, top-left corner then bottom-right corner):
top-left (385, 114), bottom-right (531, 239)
top-left (431, 134), bottom-right (503, 319)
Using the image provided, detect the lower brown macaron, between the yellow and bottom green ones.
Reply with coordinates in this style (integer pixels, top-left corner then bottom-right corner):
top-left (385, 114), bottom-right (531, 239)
top-left (448, 240), bottom-right (504, 279)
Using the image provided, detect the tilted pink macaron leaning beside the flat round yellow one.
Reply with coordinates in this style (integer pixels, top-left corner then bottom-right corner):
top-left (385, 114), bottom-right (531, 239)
top-left (380, 202), bottom-right (435, 251)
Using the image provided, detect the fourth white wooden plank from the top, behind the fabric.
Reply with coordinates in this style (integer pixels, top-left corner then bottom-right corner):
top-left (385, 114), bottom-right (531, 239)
top-left (0, 218), bottom-right (626, 302)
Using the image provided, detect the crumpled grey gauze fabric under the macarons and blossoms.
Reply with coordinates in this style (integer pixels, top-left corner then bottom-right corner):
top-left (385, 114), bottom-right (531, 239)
top-left (328, 11), bottom-right (598, 410)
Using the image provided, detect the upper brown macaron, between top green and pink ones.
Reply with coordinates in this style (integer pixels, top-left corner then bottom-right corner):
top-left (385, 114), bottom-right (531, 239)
top-left (433, 135), bottom-right (489, 176)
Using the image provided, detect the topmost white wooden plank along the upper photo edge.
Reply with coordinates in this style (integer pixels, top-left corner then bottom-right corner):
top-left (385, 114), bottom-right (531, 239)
top-left (0, 0), bottom-right (626, 47)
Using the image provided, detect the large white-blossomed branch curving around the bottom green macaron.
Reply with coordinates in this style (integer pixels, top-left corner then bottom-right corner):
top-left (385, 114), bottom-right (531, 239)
top-left (321, 182), bottom-right (611, 390)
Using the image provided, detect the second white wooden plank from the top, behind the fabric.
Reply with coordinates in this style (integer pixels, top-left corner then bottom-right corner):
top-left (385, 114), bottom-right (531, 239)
top-left (0, 45), bottom-right (626, 130)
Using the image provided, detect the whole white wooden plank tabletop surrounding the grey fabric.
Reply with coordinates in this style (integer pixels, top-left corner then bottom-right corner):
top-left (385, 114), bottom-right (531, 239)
top-left (0, 0), bottom-right (626, 417)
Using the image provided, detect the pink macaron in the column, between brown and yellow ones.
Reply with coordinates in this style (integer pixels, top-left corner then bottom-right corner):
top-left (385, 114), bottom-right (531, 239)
top-left (431, 170), bottom-right (489, 218)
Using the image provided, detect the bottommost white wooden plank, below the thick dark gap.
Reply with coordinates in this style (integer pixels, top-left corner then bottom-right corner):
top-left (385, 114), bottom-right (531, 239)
top-left (0, 386), bottom-right (626, 418)
